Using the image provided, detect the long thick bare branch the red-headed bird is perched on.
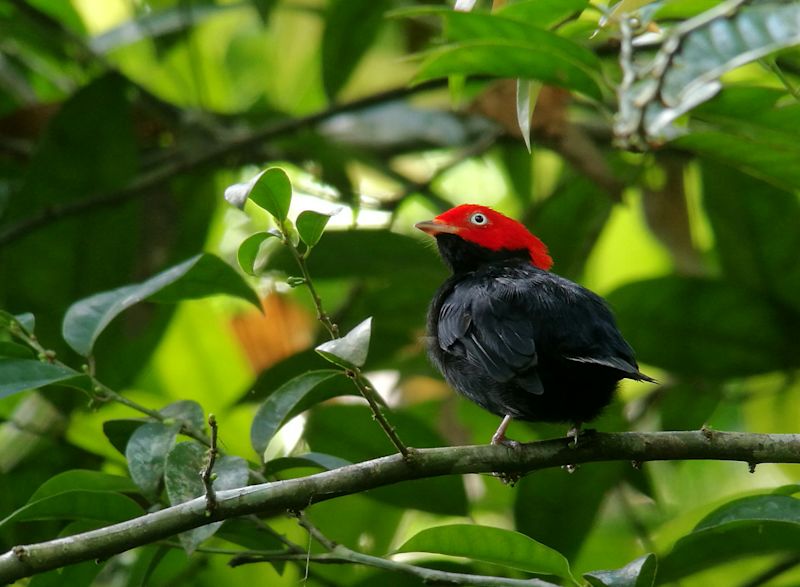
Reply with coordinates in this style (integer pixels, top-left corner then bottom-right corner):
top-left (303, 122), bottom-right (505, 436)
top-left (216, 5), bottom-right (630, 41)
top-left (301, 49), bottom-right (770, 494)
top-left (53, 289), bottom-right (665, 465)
top-left (0, 429), bottom-right (800, 584)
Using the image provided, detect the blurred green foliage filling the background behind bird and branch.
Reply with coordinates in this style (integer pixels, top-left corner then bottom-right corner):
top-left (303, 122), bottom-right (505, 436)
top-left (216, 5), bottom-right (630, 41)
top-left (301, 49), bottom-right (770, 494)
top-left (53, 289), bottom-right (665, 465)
top-left (0, 0), bottom-right (800, 587)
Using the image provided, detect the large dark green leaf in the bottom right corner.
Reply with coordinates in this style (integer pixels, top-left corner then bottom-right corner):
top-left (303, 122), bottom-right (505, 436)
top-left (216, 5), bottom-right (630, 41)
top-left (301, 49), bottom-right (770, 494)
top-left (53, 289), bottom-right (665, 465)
top-left (658, 495), bottom-right (800, 584)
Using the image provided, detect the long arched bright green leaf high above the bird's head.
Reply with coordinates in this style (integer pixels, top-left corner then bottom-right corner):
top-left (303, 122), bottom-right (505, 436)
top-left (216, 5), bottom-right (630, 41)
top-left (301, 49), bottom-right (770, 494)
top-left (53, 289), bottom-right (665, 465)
top-left (414, 39), bottom-right (602, 100)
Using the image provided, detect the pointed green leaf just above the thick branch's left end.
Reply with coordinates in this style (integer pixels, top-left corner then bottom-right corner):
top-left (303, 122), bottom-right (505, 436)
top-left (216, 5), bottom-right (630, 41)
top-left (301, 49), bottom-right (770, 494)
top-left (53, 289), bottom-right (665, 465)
top-left (0, 490), bottom-right (144, 529)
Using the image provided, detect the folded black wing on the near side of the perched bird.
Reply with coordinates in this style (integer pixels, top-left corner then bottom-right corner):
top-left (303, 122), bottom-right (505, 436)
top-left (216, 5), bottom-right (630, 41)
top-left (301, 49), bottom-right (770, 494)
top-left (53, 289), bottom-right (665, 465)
top-left (436, 277), bottom-right (544, 394)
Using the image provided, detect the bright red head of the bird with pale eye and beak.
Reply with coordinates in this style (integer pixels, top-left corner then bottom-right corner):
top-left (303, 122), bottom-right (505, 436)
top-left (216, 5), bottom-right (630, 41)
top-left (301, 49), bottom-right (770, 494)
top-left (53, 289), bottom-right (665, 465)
top-left (417, 204), bottom-right (553, 269)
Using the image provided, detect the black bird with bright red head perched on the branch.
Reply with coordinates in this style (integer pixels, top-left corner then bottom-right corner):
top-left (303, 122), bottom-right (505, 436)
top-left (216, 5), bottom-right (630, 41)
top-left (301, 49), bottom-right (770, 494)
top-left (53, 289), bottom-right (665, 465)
top-left (415, 204), bottom-right (656, 446)
